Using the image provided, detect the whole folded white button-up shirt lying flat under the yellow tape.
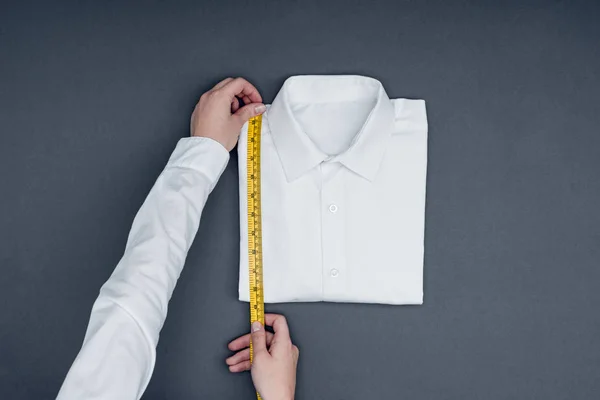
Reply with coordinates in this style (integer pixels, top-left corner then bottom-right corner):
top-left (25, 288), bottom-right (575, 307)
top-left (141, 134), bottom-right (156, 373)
top-left (238, 76), bottom-right (427, 304)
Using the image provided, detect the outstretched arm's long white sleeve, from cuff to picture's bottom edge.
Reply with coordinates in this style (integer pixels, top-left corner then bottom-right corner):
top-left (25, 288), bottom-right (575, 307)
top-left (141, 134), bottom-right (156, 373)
top-left (58, 138), bottom-right (229, 400)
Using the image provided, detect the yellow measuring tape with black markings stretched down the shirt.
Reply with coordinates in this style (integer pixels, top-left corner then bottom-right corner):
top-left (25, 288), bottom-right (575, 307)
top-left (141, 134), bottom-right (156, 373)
top-left (246, 115), bottom-right (265, 400)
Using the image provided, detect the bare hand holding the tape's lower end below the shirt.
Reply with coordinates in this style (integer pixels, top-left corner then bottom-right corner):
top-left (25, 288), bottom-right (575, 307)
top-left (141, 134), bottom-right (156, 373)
top-left (226, 314), bottom-right (300, 400)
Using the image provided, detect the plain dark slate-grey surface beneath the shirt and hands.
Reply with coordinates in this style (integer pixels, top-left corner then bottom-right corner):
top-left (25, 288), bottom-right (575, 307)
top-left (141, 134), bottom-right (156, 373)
top-left (0, 0), bottom-right (600, 400)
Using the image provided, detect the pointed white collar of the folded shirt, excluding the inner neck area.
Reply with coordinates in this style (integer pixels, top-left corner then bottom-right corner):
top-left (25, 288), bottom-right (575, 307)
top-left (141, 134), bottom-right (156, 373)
top-left (267, 75), bottom-right (394, 182)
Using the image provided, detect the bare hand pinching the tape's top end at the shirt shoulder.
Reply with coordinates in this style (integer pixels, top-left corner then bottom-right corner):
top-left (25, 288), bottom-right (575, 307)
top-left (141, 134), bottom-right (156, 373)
top-left (190, 78), bottom-right (266, 151)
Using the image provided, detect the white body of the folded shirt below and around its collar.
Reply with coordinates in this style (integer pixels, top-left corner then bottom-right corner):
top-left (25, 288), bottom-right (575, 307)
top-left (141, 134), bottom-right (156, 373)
top-left (238, 80), bottom-right (427, 304)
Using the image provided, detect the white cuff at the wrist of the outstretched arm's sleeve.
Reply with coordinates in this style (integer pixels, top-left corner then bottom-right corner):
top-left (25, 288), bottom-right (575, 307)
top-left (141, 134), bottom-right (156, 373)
top-left (167, 137), bottom-right (229, 186)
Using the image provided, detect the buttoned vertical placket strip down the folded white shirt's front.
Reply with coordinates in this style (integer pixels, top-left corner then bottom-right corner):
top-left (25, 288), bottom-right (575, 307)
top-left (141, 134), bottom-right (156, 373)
top-left (321, 162), bottom-right (348, 301)
